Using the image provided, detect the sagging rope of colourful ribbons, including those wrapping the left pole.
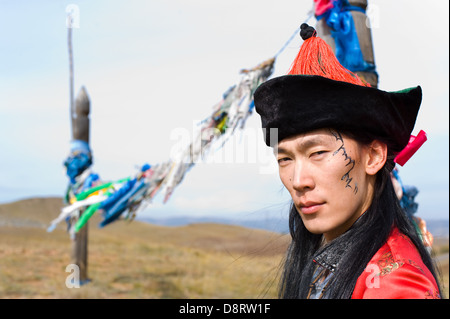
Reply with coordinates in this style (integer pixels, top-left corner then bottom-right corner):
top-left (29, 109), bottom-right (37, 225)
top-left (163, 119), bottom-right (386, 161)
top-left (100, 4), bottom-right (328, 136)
top-left (47, 10), bottom-right (313, 238)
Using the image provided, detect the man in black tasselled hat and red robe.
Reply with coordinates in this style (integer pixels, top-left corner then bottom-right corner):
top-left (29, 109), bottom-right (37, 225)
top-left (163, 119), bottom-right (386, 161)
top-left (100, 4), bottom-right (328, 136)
top-left (254, 24), bottom-right (440, 298)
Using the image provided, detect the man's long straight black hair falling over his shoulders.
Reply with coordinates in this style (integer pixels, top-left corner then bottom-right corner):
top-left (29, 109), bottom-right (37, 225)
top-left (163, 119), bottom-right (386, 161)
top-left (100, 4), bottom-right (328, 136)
top-left (279, 131), bottom-right (442, 299)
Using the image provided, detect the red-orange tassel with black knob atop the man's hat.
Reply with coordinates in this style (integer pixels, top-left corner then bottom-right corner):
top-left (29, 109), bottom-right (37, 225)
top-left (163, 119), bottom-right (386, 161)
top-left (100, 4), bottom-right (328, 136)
top-left (288, 23), bottom-right (370, 86)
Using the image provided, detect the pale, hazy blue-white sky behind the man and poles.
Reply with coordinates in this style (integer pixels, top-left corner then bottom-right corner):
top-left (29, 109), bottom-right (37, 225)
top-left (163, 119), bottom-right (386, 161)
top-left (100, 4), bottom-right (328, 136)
top-left (0, 0), bottom-right (449, 224)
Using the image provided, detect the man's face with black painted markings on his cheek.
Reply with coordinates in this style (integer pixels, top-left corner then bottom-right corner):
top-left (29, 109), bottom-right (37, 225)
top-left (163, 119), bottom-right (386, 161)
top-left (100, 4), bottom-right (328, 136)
top-left (275, 129), bottom-right (375, 240)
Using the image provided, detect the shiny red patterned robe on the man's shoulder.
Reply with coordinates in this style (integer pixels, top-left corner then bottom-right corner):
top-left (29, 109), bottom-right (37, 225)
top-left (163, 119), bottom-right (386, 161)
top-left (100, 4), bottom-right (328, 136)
top-left (352, 228), bottom-right (441, 299)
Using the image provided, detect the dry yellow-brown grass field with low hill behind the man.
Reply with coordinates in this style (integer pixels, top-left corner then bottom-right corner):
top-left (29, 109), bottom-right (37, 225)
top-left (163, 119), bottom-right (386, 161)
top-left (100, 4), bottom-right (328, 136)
top-left (0, 198), bottom-right (449, 299)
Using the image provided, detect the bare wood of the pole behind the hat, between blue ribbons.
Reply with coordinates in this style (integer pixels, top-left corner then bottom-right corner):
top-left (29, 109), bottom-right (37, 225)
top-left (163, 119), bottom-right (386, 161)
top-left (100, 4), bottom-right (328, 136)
top-left (316, 0), bottom-right (378, 88)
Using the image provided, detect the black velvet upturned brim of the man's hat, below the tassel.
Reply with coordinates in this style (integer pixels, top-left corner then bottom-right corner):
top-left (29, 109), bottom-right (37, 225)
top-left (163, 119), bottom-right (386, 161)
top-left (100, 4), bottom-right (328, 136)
top-left (254, 75), bottom-right (422, 152)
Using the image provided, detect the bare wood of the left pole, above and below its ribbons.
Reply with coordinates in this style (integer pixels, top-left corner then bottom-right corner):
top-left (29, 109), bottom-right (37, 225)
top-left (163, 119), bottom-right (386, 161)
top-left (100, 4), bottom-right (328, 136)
top-left (71, 87), bottom-right (90, 284)
